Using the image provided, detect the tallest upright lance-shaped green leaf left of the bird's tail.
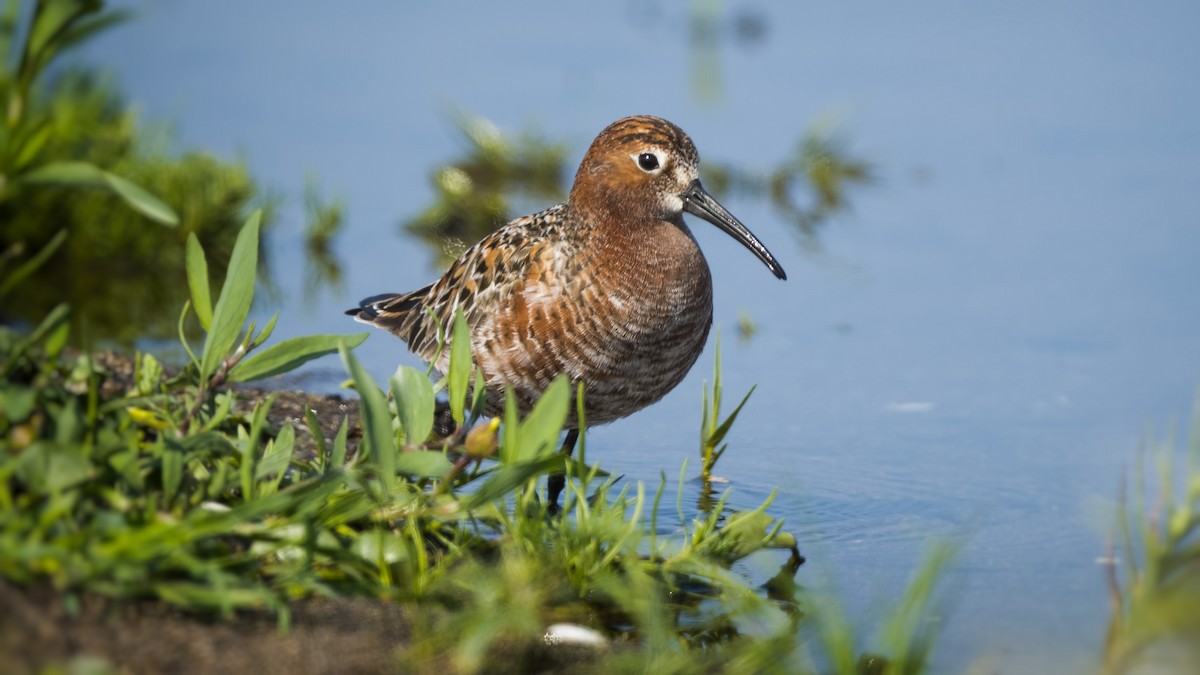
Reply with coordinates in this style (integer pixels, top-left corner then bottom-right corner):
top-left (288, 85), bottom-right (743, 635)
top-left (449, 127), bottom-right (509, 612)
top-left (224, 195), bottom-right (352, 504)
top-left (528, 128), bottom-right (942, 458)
top-left (200, 211), bottom-right (263, 380)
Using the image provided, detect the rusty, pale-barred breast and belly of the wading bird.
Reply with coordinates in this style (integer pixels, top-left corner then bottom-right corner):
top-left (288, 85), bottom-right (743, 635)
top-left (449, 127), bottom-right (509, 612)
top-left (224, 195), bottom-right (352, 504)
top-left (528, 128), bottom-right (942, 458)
top-left (476, 218), bottom-right (713, 424)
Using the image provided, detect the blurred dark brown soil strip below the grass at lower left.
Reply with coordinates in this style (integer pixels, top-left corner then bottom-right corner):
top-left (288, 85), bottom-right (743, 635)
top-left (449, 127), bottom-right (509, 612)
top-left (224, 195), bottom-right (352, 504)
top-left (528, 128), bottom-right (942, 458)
top-left (0, 583), bottom-right (410, 675)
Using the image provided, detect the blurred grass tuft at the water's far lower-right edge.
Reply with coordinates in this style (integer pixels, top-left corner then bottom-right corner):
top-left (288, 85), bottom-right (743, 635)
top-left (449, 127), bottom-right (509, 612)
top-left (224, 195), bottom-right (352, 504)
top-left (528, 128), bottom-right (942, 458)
top-left (1104, 404), bottom-right (1200, 673)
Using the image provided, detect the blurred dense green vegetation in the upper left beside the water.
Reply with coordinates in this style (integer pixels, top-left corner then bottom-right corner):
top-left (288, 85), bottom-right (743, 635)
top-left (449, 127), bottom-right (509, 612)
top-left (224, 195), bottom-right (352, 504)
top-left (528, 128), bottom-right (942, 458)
top-left (0, 0), bottom-right (262, 342)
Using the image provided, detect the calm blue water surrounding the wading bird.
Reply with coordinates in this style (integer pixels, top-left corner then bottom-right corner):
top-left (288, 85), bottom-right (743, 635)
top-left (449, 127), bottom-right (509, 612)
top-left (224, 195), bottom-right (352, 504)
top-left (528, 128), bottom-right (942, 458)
top-left (79, 1), bottom-right (1200, 673)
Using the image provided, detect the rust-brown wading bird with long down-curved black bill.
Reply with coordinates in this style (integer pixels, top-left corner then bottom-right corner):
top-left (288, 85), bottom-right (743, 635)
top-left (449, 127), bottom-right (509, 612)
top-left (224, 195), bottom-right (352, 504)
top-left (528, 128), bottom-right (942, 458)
top-left (346, 115), bottom-right (787, 506)
